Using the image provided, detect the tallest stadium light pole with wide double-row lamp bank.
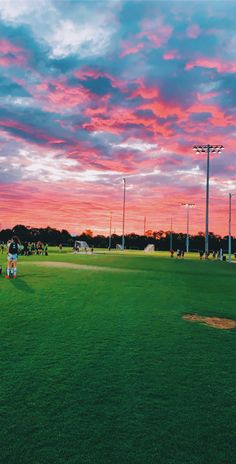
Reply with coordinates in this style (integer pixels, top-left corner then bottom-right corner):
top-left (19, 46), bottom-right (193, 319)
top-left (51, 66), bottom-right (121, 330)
top-left (193, 145), bottom-right (224, 253)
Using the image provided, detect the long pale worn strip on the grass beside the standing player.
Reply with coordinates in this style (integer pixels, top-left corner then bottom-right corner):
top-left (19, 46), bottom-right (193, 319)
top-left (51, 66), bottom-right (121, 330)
top-left (21, 261), bottom-right (140, 272)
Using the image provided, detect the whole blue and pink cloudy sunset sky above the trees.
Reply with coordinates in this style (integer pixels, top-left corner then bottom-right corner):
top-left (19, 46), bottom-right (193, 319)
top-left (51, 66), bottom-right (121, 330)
top-left (0, 0), bottom-right (236, 235)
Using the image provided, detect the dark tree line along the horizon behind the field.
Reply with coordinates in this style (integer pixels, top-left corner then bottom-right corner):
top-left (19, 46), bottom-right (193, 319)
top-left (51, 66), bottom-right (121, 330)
top-left (0, 224), bottom-right (233, 251)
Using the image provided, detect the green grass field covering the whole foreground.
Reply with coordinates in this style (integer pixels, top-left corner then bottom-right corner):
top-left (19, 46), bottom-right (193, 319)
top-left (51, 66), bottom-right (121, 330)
top-left (0, 252), bottom-right (236, 464)
